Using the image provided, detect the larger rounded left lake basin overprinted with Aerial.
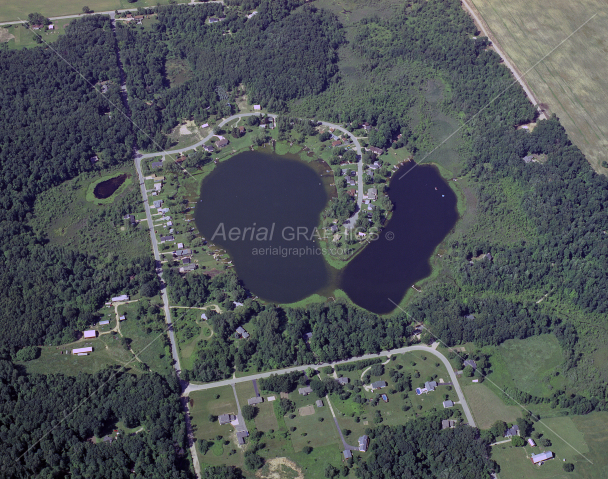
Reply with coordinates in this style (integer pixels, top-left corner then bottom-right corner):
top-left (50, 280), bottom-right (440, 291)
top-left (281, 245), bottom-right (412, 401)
top-left (195, 151), bottom-right (333, 303)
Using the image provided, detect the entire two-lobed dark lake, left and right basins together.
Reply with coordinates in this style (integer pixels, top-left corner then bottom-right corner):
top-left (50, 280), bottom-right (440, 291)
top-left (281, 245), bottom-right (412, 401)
top-left (195, 151), bottom-right (458, 314)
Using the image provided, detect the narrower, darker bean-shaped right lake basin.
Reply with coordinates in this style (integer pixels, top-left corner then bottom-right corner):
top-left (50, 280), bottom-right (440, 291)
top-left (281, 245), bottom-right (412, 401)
top-left (340, 162), bottom-right (458, 314)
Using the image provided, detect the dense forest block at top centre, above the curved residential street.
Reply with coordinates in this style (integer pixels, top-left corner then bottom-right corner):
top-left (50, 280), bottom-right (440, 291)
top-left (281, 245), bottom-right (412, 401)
top-left (117, 0), bottom-right (342, 148)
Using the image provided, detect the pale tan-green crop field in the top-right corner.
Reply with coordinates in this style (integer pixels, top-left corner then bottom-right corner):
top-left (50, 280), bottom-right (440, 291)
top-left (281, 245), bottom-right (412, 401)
top-left (472, 0), bottom-right (608, 174)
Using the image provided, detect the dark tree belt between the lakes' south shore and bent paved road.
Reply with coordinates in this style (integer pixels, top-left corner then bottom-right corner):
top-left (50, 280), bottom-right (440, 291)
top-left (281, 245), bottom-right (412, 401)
top-left (182, 302), bottom-right (411, 384)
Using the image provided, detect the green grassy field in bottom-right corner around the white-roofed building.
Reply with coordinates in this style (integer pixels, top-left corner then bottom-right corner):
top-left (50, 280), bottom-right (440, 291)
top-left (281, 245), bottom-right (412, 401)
top-left (492, 412), bottom-right (608, 479)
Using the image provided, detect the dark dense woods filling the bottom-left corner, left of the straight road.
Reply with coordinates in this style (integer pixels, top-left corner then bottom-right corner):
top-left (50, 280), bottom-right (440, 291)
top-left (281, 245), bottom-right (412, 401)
top-left (0, 361), bottom-right (189, 479)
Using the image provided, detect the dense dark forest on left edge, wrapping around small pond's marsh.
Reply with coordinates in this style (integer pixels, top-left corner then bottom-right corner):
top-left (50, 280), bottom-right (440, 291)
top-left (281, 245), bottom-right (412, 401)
top-left (0, 16), bottom-right (162, 355)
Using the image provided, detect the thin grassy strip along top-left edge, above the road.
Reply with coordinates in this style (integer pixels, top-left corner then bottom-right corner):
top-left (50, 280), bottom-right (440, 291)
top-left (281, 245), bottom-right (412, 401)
top-left (0, 0), bottom-right (175, 22)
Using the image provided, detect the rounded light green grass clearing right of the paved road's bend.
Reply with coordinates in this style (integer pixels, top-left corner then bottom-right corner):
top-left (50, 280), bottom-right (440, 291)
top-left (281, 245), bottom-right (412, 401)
top-left (489, 334), bottom-right (563, 396)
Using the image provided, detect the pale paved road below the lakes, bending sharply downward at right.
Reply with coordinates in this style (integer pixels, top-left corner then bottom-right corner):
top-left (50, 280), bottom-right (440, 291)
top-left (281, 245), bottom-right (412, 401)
top-left (184, 345), bottom-right (475, 426)
